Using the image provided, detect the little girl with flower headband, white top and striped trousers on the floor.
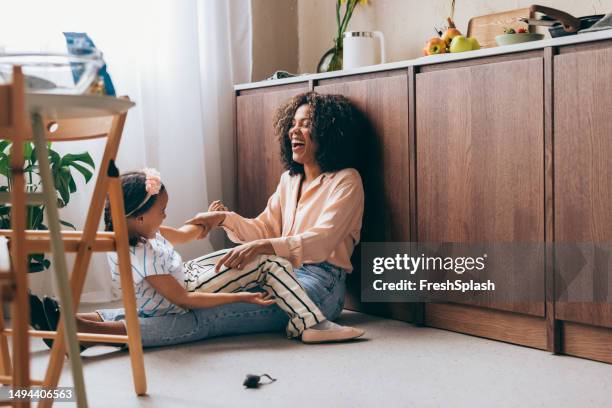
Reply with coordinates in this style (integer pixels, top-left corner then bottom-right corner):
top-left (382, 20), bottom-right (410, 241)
top-left (31, 169), bottom-right (363, 343)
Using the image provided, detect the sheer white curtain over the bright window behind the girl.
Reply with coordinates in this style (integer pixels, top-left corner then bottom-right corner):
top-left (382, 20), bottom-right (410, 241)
top-left (0, 0), bottom-right (251, 302)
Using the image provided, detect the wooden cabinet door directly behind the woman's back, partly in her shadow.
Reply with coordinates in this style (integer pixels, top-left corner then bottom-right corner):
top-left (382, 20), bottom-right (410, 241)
top-left (315, 71), bottom-right (414, 321)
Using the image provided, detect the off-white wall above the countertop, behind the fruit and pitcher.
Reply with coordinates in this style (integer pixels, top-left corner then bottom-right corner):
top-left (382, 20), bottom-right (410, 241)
top-left (298, 0), bottom-right (612, 73)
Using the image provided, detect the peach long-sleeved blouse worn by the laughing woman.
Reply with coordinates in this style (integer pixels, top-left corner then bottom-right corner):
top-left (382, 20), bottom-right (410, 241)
top-left (221, 169), bottom-right (364, 272)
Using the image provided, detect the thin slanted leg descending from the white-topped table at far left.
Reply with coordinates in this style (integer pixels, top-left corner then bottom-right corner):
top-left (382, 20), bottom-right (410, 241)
top-left (32, 114), bottom-right (87, 407)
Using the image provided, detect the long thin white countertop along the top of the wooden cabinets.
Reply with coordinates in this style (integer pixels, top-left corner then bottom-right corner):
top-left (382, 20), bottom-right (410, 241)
top-left (234, 29), bottom-right (612, 91)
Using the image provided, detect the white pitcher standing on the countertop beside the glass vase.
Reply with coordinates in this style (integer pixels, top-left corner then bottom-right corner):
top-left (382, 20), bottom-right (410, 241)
top-left (342, 31), bottom-right (386, 69)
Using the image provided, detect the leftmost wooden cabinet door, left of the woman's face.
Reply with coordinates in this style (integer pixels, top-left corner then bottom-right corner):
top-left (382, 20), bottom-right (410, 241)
top-left (236, 87), bottom-right (308, 217)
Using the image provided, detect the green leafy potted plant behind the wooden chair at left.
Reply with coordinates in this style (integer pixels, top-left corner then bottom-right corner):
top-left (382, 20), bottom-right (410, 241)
top-left (0, 140), bottom-right (95, 272)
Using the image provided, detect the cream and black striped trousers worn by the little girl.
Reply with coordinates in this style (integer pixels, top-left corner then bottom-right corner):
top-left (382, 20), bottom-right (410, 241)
top-left (184, 249), bottom-right (325, 337)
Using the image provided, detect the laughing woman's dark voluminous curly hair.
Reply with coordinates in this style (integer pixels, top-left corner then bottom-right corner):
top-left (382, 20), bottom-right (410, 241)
top-left (274, 92), bottom-right (359, 176)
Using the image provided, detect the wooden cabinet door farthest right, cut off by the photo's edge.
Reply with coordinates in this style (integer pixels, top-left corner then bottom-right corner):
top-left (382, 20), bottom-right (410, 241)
top-left (554, 47), bottom-right (612, 327)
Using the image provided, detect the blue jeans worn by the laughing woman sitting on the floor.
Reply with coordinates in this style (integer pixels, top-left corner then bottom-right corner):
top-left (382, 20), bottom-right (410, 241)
top-left (97, 263), bottom-right (346, 347)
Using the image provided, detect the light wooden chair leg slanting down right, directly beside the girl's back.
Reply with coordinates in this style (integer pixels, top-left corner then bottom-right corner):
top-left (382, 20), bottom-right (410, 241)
top-left (109, 173), bottom-right (147, 395)
